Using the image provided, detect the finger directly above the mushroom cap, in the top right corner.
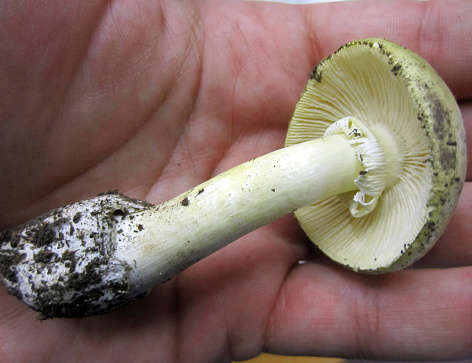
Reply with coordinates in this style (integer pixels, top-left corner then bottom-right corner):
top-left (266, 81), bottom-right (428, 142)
top-left (298, 0), bottom-right (472, 99)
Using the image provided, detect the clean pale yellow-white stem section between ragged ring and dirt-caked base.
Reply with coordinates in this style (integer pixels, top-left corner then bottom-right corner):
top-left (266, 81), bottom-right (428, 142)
top-left (120, 135), bottom-right (364, 289)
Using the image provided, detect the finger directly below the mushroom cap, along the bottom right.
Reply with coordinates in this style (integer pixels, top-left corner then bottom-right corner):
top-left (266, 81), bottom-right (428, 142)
top-left (265, 264), bottom-right (472, 360)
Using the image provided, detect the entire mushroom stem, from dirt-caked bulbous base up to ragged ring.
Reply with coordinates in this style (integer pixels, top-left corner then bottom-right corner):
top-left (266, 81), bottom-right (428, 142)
top-left (0, 117), bottom-right (379, 318)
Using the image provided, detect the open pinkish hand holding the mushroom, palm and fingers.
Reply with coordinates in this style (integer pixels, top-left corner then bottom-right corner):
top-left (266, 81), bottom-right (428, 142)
top-left (0, 0), bottom-right (472, 362)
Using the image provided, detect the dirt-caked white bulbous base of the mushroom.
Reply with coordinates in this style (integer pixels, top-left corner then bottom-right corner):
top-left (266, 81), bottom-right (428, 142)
top-left (0, 191), bottom-right (151, 319)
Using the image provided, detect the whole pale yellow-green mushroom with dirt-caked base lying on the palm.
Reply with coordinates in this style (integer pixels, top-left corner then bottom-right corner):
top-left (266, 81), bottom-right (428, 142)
top-left (0, 39), bottom-right (466, 318)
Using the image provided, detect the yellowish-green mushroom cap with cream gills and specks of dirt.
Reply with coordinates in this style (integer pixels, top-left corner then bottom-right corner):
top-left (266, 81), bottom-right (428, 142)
top-left (286, 39), bottom-right (466, 274)
